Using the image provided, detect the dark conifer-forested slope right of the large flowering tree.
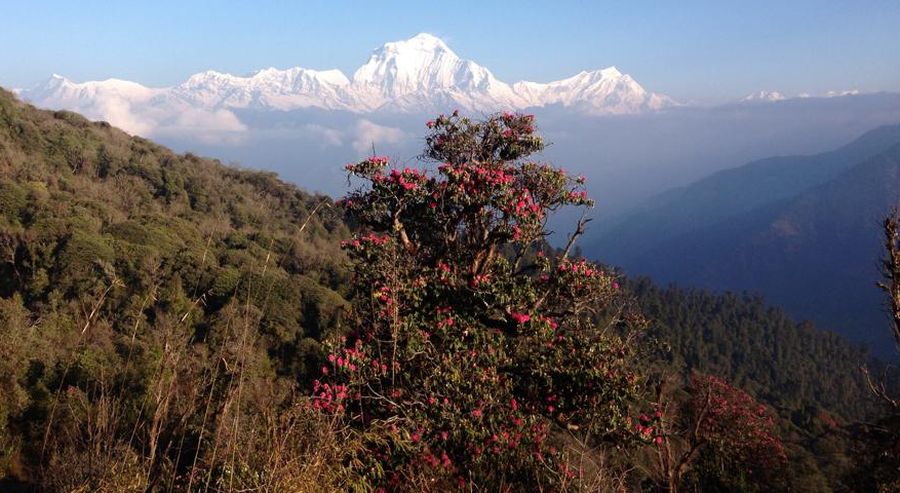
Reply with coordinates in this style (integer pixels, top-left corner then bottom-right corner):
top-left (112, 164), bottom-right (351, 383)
top-left (630, 278), bottom-right (874, 420)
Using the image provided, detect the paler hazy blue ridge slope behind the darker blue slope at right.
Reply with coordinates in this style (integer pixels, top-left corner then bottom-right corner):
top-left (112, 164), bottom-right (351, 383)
top-left (586, 125), bottom-right (900, 272)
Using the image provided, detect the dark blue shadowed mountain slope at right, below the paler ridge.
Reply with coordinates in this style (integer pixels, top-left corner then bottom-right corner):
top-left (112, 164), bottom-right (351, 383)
top-left (630, 144), bottom-right (900, 356)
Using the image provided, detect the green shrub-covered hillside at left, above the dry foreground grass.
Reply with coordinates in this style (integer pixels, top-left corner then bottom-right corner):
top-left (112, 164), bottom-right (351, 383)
top-left (0, 86), bottom-right (347, 372)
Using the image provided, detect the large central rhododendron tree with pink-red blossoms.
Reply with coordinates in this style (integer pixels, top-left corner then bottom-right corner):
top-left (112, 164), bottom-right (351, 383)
top-left (314, 112), bottom-right (640, 489)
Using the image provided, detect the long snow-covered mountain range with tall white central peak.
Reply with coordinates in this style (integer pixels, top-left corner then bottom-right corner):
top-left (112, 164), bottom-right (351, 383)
top-left (21, 33), bottom-right (674, 119)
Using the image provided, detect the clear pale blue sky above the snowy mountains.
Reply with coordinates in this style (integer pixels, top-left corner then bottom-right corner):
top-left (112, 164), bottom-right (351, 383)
top-left (0, 0), bottom-right (900, 102)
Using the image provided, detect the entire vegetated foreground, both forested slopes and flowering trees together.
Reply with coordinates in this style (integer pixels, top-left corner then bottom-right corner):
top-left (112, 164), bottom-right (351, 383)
top-left (0, 90), bottom-right (900, 492)
